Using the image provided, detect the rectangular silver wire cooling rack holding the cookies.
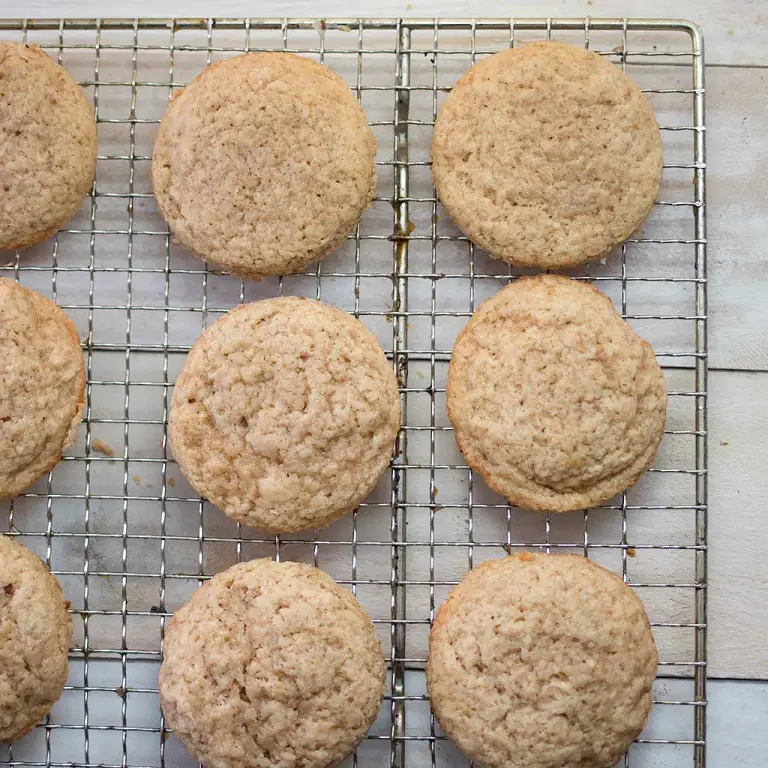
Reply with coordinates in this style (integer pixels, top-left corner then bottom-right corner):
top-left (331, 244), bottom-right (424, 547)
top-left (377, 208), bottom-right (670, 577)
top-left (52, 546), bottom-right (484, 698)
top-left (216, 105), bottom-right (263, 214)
top-left (0, 19), bottom-right (707, 768)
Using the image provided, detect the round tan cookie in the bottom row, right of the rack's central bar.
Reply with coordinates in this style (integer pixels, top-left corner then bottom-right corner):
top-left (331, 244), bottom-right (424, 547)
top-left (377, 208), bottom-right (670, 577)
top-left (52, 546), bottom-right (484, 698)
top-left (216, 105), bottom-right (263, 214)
top-left (427, 552), bottom-right (658, 768)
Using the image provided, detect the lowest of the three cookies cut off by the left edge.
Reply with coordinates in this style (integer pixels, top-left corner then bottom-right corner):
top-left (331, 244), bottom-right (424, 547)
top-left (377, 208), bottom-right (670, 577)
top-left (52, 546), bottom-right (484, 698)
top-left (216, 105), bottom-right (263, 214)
top-left (0, 536), bottom-right (72, 743)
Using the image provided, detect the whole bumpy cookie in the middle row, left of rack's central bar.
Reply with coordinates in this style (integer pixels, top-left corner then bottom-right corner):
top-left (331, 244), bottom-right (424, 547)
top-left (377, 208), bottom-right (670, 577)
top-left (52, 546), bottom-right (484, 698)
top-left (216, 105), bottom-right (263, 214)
top-left (168, 297), bottom-right (400, 533)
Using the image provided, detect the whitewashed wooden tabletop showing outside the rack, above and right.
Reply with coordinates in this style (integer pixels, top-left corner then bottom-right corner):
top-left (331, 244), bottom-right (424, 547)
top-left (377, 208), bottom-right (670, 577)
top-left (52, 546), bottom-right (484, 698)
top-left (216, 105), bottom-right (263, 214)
top-left (0, 0), bottom-right (768, 766)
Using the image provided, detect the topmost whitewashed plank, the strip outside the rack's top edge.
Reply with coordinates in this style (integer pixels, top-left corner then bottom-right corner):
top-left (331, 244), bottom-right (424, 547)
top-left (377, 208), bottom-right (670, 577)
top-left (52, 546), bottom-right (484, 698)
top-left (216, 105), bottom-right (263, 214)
top-left (0, 0), bottom-right (768, 65)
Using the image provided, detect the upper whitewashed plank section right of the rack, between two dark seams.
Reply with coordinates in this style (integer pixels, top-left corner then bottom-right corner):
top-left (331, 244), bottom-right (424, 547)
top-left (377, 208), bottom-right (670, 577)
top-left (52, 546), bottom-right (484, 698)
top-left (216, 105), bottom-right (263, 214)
top-left (707, 68), bottom-right (768, 374)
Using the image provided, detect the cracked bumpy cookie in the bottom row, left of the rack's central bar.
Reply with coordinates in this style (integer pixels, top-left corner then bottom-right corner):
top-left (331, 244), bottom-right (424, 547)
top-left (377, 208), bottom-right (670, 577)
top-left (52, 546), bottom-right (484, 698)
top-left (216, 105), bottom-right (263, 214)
top-left (160, 560), bottom-right (386, 768)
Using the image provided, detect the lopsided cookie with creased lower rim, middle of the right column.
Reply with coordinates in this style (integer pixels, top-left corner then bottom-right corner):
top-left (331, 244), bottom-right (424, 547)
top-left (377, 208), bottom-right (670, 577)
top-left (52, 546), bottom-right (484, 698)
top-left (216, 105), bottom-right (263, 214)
top-left (446, 275), bottom-right (667, 512)
